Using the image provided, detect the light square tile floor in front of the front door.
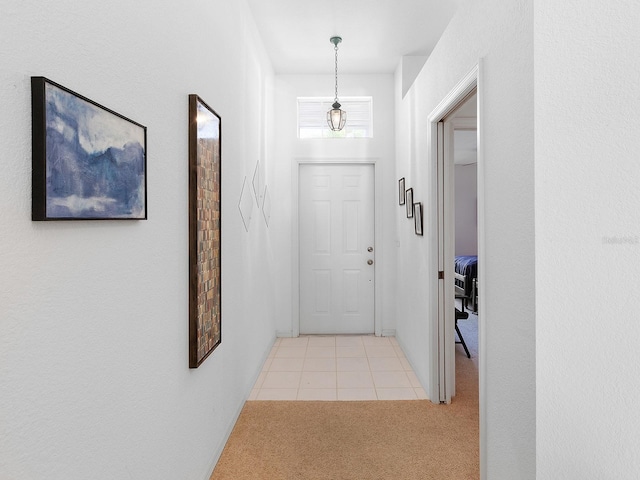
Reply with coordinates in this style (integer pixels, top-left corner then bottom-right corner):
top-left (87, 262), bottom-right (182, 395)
top-left (249, 335), bottom-right (427, 400)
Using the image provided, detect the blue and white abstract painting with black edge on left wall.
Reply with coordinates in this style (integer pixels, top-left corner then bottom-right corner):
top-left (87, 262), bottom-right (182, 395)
top-left (31, 77), bottom-right (147, 220)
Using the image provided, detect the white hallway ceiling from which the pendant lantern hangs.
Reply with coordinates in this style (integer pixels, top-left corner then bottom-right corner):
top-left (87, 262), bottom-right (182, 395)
top-left (247, 0), bottom-right (463, 74)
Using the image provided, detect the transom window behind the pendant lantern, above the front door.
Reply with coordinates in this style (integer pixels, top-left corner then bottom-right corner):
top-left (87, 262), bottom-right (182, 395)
top-left (298, 97), bottom-right (373, 139)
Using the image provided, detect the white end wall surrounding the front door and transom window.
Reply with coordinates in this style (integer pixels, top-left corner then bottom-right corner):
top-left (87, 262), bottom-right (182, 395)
top-left (272, 75), bottom-right (397, 336)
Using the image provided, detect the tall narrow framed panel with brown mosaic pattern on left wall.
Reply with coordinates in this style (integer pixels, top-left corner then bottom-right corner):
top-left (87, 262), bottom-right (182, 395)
top-left (189, 95), bottom-right (222, 368)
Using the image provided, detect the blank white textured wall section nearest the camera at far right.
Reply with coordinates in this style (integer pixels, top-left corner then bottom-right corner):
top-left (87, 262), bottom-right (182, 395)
top-left (535, 0), bottom-right (640, 480)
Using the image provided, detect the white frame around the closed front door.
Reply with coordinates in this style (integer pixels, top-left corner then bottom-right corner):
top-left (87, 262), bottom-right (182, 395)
top-left (290, 158), bottom-right (382, 337)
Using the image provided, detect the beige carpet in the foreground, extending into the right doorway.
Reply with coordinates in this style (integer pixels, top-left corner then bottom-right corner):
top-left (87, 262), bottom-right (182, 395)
top-left (211, 354), bottom-right (479, 480)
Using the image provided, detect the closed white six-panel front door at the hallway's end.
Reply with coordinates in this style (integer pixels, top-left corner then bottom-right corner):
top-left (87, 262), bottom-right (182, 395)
top-left (298, 164), bottom-right (375, 334)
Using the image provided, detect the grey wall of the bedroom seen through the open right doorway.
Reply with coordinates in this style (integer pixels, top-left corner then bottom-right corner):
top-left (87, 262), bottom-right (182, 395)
top-left (454, 163), bottom-right (478, 255)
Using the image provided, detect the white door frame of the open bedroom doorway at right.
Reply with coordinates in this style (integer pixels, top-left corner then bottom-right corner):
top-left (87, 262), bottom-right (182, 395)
top-left (427, 59), bottom-right (487, 478)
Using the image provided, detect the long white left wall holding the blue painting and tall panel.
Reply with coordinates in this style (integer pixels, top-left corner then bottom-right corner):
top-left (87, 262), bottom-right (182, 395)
top-left (0, 0), bottom-right (275, 480)
